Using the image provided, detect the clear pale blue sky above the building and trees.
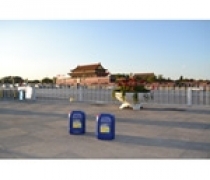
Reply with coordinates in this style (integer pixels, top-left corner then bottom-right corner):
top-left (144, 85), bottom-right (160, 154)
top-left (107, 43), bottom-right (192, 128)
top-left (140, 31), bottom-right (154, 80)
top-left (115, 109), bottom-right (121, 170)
top-left (0, 20), bottom-right (210, 79)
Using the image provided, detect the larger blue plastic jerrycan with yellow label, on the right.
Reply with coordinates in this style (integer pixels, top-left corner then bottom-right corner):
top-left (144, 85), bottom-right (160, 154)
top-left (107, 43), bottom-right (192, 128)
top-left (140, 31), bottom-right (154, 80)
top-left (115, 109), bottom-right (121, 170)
top-left (96, 114), bottom-right (115, 140)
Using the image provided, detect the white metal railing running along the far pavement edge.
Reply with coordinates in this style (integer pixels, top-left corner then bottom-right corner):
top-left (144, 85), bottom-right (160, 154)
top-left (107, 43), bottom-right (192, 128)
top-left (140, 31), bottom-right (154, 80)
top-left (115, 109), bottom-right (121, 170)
top-left (0, 86), bottom-right (210, 106)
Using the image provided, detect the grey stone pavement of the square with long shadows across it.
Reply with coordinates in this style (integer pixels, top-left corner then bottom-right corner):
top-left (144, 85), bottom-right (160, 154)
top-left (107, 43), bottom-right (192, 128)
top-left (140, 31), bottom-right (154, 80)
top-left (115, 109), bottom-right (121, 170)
top-left (0, 101), bottom-right (210, 159)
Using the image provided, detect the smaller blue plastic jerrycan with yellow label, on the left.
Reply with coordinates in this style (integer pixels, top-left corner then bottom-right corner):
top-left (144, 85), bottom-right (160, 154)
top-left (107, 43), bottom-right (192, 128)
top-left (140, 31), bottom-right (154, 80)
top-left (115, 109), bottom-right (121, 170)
top-left (69, 111), bottom-right (86, 135)
